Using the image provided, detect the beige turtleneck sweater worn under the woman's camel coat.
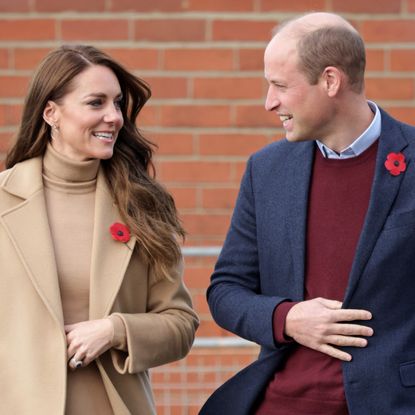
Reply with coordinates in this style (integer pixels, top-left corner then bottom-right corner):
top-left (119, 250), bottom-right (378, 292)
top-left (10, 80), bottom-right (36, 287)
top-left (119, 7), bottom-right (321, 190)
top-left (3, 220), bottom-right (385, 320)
top-left (43, 145), bottom-right (126, 415)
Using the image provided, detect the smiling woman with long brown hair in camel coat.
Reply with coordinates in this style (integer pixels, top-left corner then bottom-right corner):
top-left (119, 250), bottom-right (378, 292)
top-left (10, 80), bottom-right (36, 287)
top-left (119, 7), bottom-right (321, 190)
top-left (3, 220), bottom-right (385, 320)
top-left (0, 46), bottom-right (198, 415)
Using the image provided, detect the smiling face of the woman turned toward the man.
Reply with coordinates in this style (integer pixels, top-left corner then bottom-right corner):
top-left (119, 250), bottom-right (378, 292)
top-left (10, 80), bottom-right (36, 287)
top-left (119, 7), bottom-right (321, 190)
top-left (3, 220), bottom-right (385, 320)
top-left (44, 65), bottom-right (123, 161)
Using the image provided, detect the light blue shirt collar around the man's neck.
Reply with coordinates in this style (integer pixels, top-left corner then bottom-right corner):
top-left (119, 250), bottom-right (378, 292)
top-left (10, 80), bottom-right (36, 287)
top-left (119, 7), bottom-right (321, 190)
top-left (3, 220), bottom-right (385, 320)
top-left (316, 101), bottom-right (382, 159)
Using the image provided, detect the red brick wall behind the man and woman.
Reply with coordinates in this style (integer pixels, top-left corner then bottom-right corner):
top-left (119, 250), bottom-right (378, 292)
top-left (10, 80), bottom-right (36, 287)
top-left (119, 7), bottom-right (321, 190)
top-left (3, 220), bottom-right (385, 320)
top-left (0, 0), bottom-right (415, 414)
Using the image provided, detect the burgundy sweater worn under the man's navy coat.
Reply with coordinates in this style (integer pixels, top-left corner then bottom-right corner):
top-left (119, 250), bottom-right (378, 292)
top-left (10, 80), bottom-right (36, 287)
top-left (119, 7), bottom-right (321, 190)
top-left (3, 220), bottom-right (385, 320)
top-left (256, 142), bottom-right (377, 415)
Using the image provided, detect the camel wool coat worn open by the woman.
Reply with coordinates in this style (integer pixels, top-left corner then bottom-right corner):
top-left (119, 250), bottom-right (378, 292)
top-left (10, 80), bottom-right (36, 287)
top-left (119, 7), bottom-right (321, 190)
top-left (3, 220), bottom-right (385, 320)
top-left (0, 157), bottom-right (198, 415)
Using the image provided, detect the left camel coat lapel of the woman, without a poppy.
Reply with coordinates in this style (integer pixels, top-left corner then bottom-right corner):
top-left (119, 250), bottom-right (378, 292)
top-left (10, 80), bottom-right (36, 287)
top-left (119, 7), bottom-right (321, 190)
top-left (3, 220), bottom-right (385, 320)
top-left (0, 157), bottom-right (63, 327)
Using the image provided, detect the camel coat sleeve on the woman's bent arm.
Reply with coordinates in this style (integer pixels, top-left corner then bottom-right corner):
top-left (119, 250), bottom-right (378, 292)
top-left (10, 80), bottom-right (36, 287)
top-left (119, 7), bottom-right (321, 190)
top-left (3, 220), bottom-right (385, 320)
top-left (110, 263), bottom-right (199, 374)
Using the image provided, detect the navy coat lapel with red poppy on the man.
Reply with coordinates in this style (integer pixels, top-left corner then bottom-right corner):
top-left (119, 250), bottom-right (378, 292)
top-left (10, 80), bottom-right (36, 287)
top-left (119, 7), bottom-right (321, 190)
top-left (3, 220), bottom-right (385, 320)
top-left (344, 112), bottom-right (410, 307)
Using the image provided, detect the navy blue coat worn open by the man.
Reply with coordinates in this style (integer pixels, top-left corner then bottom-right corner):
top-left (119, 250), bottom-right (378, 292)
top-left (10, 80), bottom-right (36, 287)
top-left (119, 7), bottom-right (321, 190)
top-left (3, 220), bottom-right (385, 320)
top-left (200, 111), bottom-right (415, 415)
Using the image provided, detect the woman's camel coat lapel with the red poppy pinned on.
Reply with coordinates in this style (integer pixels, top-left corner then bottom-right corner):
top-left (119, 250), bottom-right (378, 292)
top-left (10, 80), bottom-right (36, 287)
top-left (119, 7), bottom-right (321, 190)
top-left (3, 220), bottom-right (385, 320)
top-left (89, 169), bottom-right (135, 319)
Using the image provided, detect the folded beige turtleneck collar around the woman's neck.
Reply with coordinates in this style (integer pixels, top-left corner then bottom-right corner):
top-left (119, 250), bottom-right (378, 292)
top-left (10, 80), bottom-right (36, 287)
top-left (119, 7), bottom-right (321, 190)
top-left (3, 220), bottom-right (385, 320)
top-left (43, 143), bottom-right (100, 183)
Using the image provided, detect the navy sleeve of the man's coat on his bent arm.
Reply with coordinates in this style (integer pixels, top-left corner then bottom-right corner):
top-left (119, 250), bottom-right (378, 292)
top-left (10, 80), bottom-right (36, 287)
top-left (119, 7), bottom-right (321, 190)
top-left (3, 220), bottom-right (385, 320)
top-left (207, 158), bottom-right (286, 348)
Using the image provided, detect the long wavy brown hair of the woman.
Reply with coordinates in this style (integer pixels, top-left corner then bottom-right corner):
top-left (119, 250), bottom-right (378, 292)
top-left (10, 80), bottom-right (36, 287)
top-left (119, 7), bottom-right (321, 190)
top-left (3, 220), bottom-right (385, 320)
top-left (6, 45), bottom-right (185, 278)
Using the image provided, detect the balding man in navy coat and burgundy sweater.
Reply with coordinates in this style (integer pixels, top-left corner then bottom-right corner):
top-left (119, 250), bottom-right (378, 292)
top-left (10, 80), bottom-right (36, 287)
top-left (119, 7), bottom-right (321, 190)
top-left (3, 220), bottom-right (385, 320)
top-left (200, 13), bottom-right (415, 415)
